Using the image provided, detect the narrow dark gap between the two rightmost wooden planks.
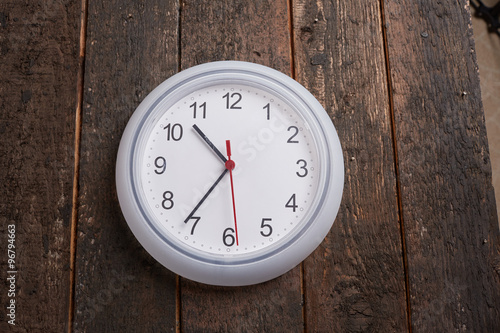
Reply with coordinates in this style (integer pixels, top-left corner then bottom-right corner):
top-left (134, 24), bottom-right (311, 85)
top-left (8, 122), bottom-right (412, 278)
top-left (380, 0), bottom-right (412, 333)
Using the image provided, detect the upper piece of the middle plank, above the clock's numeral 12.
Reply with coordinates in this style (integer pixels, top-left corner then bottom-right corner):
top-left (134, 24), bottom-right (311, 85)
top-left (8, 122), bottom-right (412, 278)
top-left (181, 0), bottom-right (291, 75)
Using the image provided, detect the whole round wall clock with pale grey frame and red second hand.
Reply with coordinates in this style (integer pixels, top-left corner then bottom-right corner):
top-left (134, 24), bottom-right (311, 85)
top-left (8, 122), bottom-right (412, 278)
top-left (116, 61), bottom-right (344, 286)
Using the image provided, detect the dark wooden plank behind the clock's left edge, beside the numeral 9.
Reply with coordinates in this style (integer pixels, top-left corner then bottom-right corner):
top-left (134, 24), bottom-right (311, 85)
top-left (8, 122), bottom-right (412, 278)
top-left (74, 0), bottom-right (178, 332)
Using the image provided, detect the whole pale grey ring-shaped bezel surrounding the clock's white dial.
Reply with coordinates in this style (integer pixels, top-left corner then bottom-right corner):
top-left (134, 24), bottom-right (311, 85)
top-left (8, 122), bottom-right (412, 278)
top-left (116, 61), bottom-right (344, 285)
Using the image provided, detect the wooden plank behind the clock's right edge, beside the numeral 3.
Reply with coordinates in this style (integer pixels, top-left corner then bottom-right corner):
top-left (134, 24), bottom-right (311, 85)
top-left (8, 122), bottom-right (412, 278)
top-left (293, 0), bottom-right (407, 332)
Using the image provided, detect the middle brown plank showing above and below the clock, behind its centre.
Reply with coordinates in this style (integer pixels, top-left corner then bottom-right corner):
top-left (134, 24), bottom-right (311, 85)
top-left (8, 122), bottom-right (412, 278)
top-left (181, 0), bottom-right (303, 332)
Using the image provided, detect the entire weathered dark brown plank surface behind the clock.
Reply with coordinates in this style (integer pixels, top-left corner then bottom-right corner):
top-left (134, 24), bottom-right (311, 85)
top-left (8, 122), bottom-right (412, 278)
top-left (0, 0), bottom-right (500, 332)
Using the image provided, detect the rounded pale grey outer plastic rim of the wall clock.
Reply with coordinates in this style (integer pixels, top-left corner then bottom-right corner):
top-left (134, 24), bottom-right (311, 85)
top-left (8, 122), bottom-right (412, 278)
top-left (116, 61), bottom-right (344, 286)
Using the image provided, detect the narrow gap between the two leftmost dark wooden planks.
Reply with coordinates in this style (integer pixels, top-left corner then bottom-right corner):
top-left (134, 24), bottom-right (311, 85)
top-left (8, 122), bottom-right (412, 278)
top-left (68, 0), bottom-right (88, 333)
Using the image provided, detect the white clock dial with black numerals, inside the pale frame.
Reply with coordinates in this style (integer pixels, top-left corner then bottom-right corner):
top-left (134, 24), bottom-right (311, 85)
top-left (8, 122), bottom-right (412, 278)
top-left (138, 83), bottom-right (320, 257)
